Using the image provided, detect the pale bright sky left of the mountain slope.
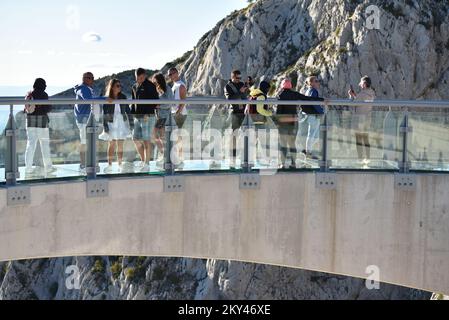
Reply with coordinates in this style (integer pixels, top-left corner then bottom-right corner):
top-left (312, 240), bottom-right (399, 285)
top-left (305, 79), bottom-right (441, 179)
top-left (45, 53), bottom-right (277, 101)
top-left (0, 0), bottom-right (247, 95)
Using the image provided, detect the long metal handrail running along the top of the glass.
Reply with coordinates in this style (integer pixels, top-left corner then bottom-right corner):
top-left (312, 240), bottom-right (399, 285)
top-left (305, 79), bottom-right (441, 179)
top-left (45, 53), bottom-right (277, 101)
top-left (0, 97), bottom-right (449, 109)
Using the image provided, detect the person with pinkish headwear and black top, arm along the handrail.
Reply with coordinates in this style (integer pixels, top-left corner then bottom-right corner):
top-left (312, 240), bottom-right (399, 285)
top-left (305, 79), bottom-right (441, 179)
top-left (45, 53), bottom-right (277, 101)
top-left (276, 79), bottom-right (324, 168)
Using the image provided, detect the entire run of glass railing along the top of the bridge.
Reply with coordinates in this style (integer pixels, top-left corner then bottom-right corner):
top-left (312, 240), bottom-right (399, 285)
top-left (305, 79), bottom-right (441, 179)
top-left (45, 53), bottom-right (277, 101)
top-left (0, 97), bottom-right (449, 185)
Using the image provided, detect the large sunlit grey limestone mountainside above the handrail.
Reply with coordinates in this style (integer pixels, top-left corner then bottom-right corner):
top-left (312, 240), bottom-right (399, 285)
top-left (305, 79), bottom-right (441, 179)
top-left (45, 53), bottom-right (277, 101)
top-left (175, 0), bottom-right (449, 99)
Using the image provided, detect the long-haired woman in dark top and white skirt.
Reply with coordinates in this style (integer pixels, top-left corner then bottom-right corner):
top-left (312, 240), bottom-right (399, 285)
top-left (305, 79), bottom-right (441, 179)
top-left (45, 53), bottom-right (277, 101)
top-left (101, 79), bottom-right (133, 174)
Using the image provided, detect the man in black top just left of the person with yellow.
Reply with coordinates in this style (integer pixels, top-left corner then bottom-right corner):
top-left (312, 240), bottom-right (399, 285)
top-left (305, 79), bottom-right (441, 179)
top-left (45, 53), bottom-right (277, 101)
top-left (225, 70), bottom-right (249, 168)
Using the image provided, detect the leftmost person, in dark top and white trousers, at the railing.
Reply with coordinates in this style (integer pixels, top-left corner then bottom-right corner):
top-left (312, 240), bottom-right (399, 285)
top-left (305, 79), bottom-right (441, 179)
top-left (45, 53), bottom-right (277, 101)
top-left (24, 78), bottom-right (56, 175)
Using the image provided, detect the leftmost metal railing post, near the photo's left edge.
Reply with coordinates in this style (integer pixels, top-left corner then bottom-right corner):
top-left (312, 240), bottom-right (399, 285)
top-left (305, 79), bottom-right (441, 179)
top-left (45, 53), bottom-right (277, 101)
top-left (5, 105), bottom-right (19, 186)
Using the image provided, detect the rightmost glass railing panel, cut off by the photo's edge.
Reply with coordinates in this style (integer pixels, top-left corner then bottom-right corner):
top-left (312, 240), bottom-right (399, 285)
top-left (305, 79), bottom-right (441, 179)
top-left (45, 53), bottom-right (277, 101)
top-left (408, 109), bottom-right (449, 171)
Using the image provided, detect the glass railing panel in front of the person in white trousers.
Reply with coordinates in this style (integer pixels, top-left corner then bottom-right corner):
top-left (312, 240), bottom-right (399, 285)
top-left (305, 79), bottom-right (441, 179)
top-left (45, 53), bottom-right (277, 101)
top-left (15, 106), bottom-right (86, 181)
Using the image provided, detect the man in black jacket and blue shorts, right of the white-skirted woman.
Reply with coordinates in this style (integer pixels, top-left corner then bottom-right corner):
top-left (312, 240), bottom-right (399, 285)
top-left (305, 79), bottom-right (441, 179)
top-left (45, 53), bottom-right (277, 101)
top-left (131, 68), bottom-right (159, 172)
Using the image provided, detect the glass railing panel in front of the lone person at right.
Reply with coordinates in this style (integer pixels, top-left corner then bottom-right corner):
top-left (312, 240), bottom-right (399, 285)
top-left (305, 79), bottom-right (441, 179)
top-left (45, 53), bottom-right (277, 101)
top-left (328, 106), bottom-right (404, 170)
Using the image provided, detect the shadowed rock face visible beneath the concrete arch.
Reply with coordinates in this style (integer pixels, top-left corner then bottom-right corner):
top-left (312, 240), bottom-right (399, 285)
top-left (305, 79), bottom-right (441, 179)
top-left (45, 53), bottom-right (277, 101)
top-left (0, 257), bottom-right (431, 300)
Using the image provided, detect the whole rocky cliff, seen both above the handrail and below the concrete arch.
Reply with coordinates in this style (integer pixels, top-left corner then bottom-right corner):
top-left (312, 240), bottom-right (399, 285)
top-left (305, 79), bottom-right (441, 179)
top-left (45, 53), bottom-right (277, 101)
top-left (0, 0), bottom-right (449, 299)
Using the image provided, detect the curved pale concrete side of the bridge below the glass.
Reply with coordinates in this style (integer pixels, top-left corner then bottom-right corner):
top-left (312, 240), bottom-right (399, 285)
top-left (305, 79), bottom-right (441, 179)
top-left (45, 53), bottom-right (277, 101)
top-left (0, 172), bottom-right (449, 293)
